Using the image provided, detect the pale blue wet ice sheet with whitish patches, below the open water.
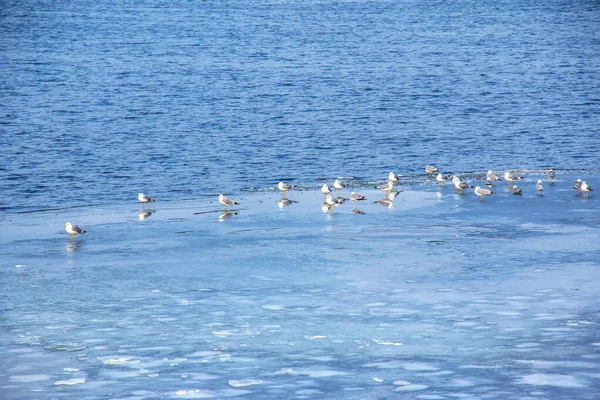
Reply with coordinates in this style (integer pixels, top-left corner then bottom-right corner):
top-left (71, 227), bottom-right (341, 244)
top-left (0, 178), bottom-right (600, 399)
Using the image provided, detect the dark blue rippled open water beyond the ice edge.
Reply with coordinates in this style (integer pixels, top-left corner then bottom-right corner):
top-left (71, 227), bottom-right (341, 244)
top-left (0, 1), bottom-right (600, 210)
